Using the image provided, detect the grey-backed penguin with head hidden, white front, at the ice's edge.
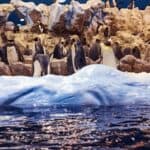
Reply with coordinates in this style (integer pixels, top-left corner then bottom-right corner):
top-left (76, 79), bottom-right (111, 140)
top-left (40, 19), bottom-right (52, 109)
top-left (32, 54), bottom-right (50, 77)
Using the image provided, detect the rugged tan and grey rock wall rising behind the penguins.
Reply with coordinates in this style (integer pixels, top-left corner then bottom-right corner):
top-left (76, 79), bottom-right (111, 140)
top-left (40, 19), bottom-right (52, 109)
top-left (0, 0), bottom-right (150, 74)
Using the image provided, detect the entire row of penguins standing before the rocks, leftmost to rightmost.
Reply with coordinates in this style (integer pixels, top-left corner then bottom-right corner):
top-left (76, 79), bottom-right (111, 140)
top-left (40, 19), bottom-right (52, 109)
top-left (0, 27), bottom-right (144, 77)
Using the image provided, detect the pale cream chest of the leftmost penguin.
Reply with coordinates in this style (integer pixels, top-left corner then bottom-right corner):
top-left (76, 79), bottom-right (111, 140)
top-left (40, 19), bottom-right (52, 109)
top-left (7, 46), bottom-right (19, 64)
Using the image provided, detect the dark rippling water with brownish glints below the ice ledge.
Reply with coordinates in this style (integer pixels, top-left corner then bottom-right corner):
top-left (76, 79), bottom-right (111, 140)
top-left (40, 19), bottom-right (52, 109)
top-left (0, 104), bottom-right (150, 150)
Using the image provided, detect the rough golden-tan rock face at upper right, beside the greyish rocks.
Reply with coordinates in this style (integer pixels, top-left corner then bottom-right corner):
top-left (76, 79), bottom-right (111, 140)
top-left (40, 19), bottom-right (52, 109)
top-left (105, 7), bottom-right (150, 50)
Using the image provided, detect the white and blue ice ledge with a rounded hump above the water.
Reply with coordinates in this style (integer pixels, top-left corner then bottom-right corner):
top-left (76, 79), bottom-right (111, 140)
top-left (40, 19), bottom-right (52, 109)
top-left (0, 65), bottom-right (150, 108)
